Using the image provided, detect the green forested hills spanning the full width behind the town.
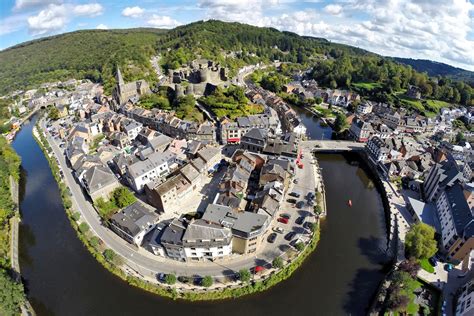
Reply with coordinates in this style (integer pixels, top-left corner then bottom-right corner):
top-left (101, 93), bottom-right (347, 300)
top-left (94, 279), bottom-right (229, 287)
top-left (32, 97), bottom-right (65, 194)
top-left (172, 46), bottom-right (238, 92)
top-left (0, 20), bottom-right (474, 105)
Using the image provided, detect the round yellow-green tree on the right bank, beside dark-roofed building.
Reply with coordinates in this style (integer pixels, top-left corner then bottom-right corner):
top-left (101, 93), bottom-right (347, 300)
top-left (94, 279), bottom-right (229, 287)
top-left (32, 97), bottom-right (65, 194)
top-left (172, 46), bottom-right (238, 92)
top-left (405, 223), bottom-right (438, 259)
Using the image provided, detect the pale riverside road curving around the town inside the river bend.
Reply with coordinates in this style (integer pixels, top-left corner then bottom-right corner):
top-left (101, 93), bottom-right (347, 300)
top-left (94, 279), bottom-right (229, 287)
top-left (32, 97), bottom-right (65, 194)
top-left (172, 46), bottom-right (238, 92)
top-left (41, 120), bottom-right (314, 281)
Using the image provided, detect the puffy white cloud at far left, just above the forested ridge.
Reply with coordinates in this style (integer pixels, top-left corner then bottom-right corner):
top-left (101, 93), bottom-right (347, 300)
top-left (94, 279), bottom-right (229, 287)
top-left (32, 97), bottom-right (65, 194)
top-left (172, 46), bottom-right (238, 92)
top-left (28, 4), bottom-right (68, 36)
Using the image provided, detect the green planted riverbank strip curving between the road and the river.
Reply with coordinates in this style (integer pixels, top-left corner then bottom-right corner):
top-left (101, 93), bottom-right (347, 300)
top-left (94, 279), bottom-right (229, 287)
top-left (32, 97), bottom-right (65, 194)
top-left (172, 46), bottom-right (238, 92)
top-left (33, 115), bottom-right (319, 301)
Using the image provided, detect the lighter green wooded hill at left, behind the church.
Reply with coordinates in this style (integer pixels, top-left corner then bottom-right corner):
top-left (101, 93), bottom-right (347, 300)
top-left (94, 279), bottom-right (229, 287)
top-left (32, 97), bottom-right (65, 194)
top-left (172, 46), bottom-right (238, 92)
top-left (0, 29), bottom-right (167, 94)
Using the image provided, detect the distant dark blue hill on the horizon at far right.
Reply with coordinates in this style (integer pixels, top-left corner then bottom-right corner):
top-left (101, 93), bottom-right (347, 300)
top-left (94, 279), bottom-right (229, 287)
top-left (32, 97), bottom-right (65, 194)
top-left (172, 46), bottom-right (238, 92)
top-left (394, 57), bottom-right (474, 84)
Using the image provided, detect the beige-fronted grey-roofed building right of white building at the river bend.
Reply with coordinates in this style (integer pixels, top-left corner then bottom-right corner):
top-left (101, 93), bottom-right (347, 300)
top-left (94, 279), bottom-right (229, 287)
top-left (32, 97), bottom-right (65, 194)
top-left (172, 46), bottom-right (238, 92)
top-left (202, 204), bottom-right (270, 254)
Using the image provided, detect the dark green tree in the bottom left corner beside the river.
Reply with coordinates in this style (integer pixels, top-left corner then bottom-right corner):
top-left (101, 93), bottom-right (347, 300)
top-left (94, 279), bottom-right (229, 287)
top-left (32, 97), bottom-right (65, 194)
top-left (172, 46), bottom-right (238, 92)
top-left (0, 269), bottom-right (25, 315)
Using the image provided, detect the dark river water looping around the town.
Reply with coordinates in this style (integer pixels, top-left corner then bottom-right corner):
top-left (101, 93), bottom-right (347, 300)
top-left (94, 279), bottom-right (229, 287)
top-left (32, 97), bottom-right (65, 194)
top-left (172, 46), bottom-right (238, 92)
top-left (13, 113), bottom-right (386, 316)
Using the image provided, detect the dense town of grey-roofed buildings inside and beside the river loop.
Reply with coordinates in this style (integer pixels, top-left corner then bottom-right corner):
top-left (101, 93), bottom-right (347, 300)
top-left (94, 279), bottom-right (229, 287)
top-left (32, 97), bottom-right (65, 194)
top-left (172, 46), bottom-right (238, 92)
top-left (1, 55), bottom-right (474, 315)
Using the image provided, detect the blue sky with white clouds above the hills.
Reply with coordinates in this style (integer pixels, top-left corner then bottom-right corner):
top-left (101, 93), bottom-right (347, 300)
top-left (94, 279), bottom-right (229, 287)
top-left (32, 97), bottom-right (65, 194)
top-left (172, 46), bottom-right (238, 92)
top-left (0, 0), bottom-right (474, 71)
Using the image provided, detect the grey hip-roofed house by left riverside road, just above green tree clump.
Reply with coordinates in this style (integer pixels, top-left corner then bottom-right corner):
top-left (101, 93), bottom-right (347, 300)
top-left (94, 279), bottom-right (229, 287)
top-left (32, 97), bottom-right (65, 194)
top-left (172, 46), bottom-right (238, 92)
top-left (82, 166), bottom-right (120, 201)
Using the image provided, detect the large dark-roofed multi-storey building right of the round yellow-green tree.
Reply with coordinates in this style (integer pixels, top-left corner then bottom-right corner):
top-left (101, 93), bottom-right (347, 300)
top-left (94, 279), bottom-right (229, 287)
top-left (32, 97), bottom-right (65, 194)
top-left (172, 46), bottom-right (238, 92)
top-left (436, 184), bottom-right (474, 263)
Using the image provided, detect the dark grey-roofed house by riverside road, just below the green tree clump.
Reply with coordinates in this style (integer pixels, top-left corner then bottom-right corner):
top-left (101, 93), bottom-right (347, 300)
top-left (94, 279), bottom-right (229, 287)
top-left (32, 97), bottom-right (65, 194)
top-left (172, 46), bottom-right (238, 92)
top-left (110, 201), bottom-right (158, 246)
